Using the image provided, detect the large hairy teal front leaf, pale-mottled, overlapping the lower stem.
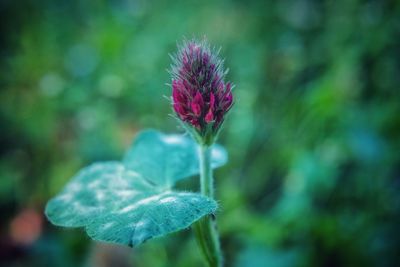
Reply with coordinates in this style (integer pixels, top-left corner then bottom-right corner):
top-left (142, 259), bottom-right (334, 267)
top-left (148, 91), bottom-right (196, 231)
top-left (45, 162), bottom-right (217, 246)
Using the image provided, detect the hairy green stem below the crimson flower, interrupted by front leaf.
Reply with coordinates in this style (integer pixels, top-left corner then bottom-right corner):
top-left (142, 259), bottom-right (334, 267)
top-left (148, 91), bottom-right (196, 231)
top-left (194, 145), bottom-right (222, 267)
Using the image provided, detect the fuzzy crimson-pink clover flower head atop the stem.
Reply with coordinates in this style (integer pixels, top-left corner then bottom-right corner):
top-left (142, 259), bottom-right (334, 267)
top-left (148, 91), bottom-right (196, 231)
top-left (171, 40), bottom-right (233, 144)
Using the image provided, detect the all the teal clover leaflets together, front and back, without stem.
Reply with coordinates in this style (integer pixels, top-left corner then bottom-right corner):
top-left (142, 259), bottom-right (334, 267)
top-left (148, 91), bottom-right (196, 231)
top-left (45, 131), bottom-right (226, 246)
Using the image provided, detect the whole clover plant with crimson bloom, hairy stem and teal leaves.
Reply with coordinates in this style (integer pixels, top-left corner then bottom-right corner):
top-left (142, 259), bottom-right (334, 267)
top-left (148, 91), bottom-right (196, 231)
top-left (45, 40), bottom-right (233, 267)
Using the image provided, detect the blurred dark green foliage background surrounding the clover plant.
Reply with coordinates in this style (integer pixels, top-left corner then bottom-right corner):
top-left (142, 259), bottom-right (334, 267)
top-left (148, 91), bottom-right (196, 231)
top-left (0, 0), bottom-right (400, 267)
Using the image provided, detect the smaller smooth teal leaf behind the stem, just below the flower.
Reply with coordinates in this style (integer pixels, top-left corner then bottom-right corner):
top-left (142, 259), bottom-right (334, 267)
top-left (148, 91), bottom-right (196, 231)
top-left (123, 130), bottom-right (227, 188)
